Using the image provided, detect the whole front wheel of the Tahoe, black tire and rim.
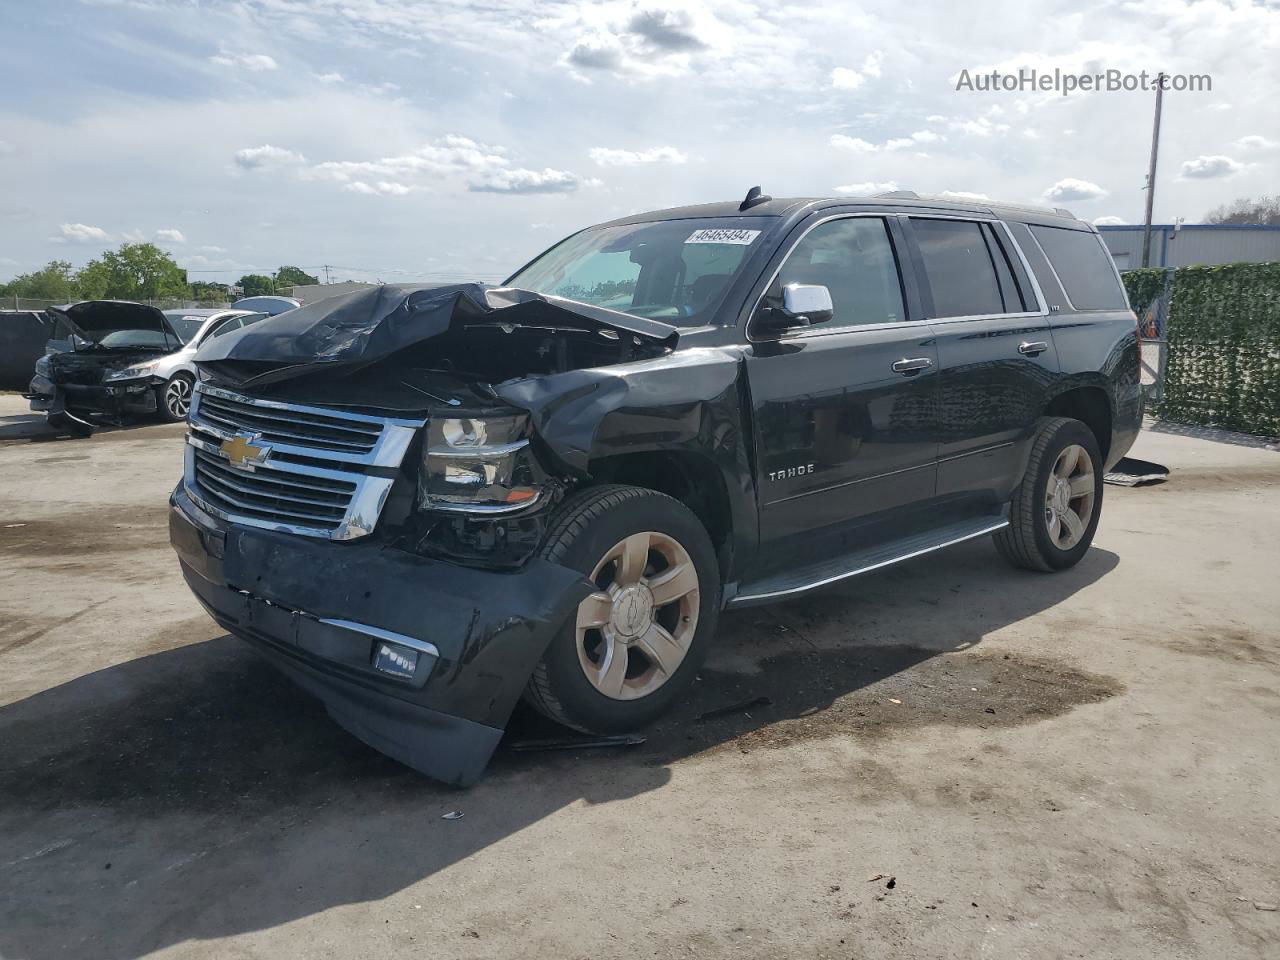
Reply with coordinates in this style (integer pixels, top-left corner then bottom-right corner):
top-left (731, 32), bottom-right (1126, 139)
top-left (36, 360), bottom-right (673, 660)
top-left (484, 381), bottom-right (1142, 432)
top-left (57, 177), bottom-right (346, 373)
top-left (525, 485), bottom-right (721, 733)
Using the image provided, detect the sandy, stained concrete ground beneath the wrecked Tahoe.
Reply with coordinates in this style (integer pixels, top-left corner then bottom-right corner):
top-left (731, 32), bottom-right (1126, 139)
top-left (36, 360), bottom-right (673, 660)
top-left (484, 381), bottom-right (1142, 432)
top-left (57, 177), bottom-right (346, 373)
top-left (0, 397), bottom-right (1280, 960)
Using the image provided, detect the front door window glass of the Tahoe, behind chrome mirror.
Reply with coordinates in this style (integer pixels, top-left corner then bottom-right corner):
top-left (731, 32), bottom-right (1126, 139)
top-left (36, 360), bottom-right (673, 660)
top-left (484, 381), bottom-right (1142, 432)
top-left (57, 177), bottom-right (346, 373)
top-left (769, 216), bottom-right (906, 330)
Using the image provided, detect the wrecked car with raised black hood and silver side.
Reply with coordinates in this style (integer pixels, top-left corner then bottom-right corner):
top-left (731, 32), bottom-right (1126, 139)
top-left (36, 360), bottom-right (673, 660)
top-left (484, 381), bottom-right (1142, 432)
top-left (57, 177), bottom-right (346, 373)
top-left (26, 300), bottom-right (266, 435)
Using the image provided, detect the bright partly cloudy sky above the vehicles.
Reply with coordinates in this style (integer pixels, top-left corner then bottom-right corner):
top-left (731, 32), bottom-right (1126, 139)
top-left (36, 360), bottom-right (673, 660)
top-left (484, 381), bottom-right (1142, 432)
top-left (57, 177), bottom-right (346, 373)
top-left (0, 0), bottom-right (1280, 283)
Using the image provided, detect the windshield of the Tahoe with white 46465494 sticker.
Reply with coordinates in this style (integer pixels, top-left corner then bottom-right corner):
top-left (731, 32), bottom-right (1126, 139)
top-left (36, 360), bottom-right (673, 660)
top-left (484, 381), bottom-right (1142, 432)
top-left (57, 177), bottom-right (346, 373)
top-left (507, 216), bottom-right (772, 325)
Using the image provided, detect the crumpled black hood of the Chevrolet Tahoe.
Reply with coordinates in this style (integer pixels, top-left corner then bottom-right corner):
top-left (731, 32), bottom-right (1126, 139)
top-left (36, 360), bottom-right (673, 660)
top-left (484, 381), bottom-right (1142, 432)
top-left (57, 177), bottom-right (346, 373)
top-left (196, 283), bottom-right (678, 385)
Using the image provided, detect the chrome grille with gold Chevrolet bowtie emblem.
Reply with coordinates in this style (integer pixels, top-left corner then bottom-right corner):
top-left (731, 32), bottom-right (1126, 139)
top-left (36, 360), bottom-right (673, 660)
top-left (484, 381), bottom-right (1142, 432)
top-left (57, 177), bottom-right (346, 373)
top-left (184, 384), bottom-right (424, 540)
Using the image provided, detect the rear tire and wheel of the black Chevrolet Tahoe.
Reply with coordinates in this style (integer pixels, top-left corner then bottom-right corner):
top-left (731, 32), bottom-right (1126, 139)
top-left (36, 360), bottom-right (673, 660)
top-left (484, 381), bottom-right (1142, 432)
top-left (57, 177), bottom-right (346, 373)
top-left (995, 417), bottom-right (1102, 572)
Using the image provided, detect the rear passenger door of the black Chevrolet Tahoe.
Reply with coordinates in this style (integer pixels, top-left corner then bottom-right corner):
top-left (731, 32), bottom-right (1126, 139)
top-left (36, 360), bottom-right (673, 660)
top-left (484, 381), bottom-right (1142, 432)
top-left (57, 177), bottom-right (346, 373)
top-left (909, 215), bottom-right (1059, 520)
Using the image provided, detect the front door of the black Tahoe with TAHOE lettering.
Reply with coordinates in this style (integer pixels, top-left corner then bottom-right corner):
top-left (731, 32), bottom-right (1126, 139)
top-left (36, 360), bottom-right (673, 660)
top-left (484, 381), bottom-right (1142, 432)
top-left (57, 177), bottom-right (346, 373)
top-left (746, 216), bottom-right (938, 572)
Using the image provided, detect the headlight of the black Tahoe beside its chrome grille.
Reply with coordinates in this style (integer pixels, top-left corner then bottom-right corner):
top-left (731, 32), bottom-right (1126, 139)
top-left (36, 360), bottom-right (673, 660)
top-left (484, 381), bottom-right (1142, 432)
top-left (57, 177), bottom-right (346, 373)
top-left (417, 413), bottom-right (539, 513)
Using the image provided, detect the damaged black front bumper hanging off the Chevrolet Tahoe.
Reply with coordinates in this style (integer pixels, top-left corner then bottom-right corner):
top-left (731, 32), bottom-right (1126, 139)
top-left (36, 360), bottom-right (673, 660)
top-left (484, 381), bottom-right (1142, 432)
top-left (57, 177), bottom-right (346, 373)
top-left (169, 485), bottom-right (591, 786)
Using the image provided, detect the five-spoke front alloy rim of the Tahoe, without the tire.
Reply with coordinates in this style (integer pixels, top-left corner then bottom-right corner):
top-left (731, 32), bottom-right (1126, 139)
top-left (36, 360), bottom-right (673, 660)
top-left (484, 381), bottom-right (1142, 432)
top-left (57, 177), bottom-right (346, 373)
top-left (576, 531), bottom-right (699, 700)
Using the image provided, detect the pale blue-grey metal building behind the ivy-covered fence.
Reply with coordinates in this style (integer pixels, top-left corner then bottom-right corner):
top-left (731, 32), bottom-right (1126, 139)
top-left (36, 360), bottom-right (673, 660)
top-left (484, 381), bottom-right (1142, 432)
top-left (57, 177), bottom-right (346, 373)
top-left (1098, 223), bottom-right (1280, 270)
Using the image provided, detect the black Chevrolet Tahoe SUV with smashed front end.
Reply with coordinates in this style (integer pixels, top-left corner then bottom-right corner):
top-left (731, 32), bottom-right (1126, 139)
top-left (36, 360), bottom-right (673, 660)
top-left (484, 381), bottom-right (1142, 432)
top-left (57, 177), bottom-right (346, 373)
top-left (170, 188), bottom-right (1142, 785)
